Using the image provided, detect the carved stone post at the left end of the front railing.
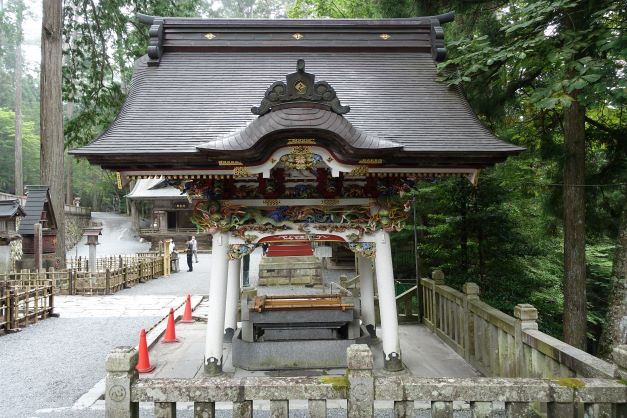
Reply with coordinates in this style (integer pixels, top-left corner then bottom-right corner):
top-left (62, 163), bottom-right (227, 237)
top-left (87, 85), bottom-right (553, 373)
top-left (105, 347), bottom-right (139, 418)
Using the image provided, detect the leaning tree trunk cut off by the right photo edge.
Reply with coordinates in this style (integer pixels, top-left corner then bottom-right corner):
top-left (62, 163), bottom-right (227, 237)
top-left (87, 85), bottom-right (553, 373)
top-left (599, 194), bottom-right (627, 356)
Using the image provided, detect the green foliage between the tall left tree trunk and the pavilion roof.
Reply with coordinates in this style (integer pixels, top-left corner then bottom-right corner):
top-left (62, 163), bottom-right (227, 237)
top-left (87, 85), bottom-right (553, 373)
top-left (63, 0), bottom-right (203, 147)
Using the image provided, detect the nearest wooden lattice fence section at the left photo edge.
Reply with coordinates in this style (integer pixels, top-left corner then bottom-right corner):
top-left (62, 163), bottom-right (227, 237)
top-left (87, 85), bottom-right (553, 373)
top-left (0, 274), bottom-right (54, 332)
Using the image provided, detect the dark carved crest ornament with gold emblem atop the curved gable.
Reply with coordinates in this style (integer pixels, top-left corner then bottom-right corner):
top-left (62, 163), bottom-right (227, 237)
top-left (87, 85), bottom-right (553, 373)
top-left (250, 59), bottom-right (350, 116)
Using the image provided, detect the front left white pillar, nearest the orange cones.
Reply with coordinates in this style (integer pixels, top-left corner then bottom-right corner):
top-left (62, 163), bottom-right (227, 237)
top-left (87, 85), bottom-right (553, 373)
top-left (205, 232), bottom-right (229, 375)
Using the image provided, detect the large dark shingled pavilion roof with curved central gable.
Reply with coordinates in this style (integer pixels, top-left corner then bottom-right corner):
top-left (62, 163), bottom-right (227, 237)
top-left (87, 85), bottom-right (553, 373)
top-left (72, 15), bottom-right (522, 170)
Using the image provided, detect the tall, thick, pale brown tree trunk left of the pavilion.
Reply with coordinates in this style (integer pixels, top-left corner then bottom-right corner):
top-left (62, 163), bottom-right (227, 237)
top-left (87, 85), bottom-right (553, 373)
top-left (40, 0), bottom-right (65, 267)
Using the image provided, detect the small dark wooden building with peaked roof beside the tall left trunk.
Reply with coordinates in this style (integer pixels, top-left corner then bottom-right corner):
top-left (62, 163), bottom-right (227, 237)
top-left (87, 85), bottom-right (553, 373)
top-left (18, 185), bottom-right (57, 268)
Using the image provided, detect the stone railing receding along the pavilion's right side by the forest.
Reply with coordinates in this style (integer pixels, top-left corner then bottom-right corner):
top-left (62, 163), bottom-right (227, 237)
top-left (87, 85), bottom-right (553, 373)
top-left (421, 272), bottom-right (616, 378)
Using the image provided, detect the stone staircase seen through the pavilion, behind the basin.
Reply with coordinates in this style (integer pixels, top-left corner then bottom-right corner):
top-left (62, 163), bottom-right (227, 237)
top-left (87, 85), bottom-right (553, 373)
top-left (258, 255), bottom-right (322, 286)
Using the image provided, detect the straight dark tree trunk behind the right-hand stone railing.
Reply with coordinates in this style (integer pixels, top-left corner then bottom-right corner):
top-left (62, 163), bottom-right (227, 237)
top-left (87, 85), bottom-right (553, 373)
top-left (564, 97), bottom-right (587, 350)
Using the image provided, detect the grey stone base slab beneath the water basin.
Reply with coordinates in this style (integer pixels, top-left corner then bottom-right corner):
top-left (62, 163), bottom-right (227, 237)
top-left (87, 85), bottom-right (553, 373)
top-left (232, 329), bottom-right (370, 370)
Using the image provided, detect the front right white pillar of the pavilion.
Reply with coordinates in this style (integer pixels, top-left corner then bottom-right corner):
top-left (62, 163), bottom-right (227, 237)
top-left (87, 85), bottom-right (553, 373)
top-left (375, 231), bottom-right (403, 371)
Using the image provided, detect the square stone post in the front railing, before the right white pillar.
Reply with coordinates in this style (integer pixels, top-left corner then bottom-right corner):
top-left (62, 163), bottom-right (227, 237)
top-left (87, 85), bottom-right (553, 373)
top-left (346, 344), bottom-right (374, 418)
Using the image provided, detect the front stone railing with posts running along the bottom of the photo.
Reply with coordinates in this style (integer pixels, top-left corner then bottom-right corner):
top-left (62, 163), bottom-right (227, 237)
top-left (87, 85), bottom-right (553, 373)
top-left (105, 345), bottom-right (627, 418)
